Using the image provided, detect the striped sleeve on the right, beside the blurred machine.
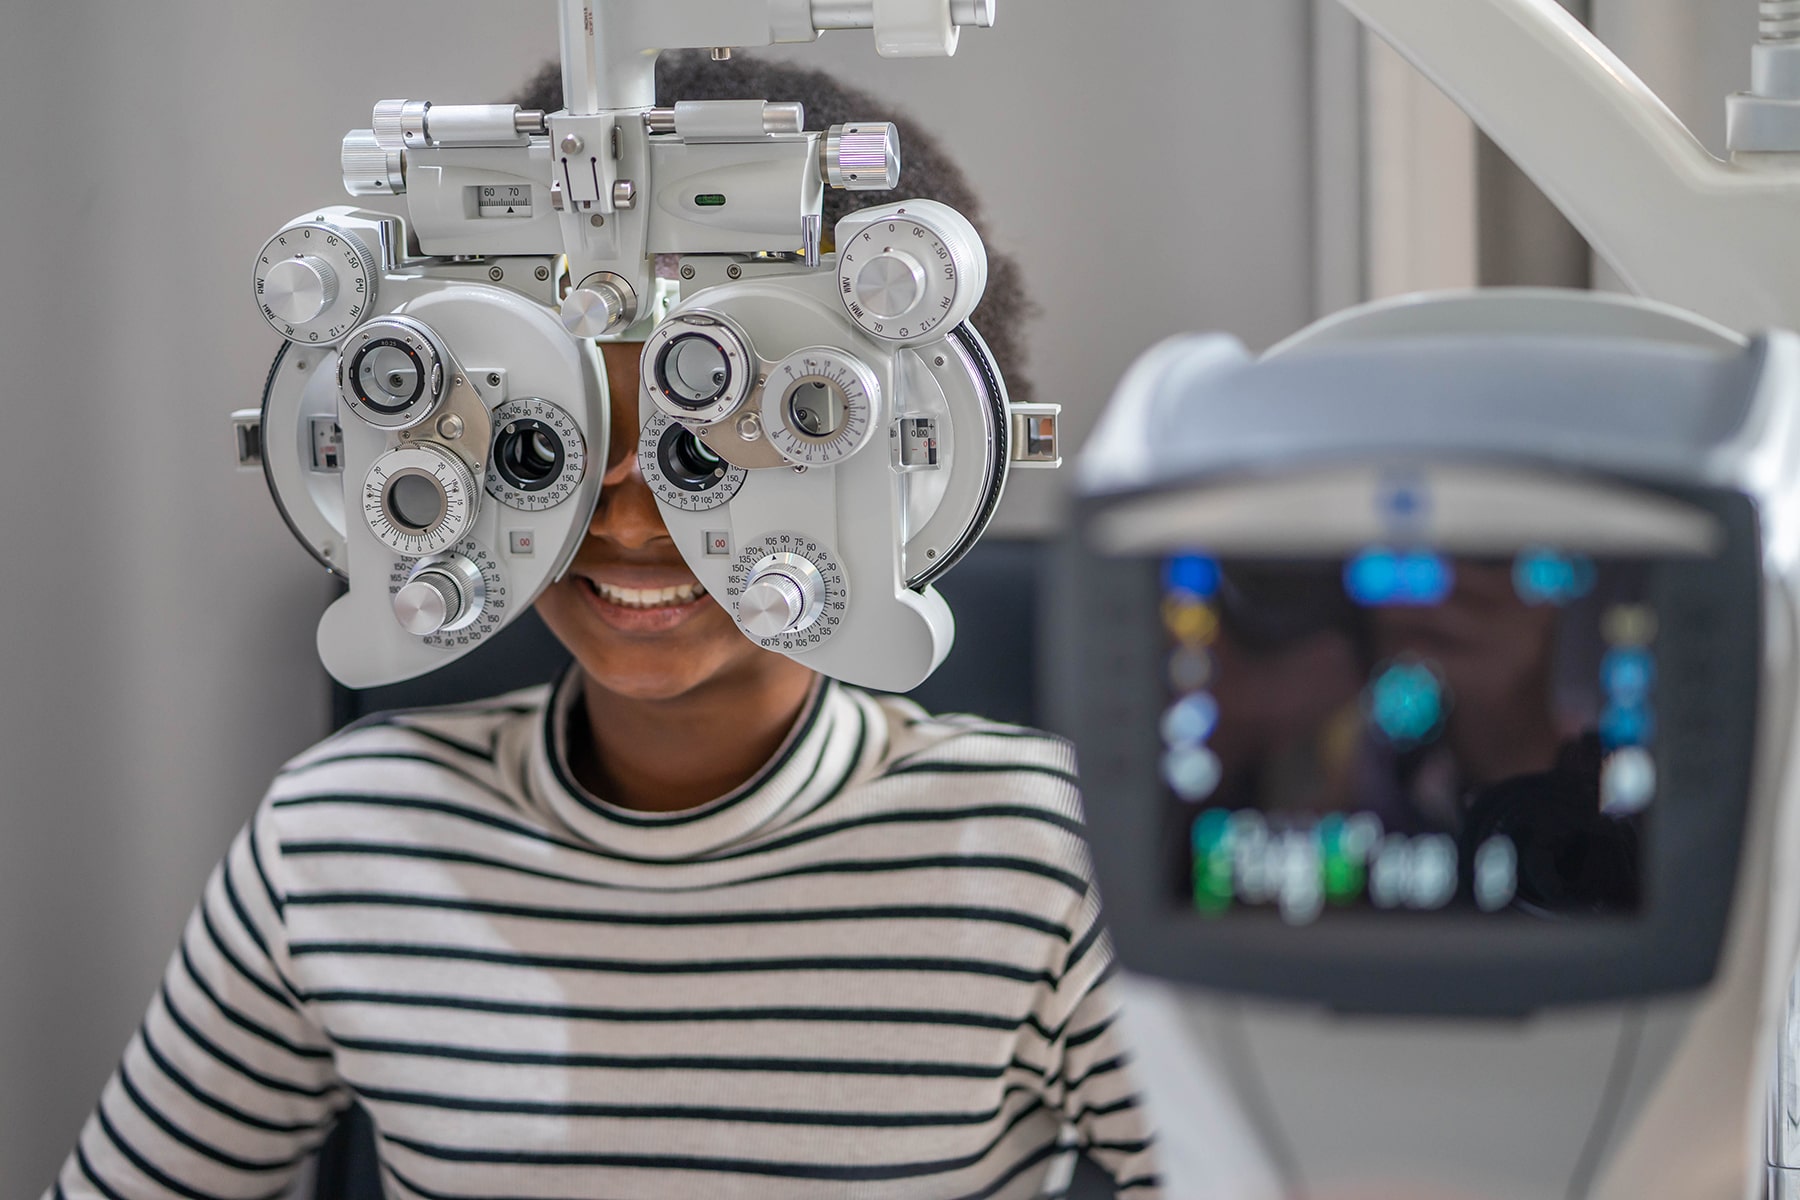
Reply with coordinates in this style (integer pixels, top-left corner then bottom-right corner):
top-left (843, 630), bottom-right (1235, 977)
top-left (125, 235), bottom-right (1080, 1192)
top-left (1039, 887), bottom-right (1161, 1200)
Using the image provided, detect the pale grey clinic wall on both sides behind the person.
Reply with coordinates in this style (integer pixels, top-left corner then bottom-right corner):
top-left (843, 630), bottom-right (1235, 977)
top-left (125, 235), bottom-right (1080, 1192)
top-left (0, 0), bottom-right (1755, 1196)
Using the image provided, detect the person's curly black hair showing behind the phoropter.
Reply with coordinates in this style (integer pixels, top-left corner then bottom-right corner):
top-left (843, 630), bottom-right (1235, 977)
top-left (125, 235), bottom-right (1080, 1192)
top-left (517, 50), bottom-right (1033, 401)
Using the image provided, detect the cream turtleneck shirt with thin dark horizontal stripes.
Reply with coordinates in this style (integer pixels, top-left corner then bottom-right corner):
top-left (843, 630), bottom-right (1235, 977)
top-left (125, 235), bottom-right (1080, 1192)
top-left (47, 675), bottom-right (1157, 1200)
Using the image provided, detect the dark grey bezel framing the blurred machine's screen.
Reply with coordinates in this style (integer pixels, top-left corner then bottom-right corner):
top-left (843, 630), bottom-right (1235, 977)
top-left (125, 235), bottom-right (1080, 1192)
top-left (1055, 473), bottom-right (1762, 1016)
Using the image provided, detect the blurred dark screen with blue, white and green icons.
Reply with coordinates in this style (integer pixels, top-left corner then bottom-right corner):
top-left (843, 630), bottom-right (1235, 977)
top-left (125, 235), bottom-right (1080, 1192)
top-left (1159, 547), bottom-right (1658, 925)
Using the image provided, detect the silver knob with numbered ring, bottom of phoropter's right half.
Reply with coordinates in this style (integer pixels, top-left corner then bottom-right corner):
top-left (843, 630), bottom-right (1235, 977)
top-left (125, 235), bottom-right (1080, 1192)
top-left (725, 533), bottom-right (850, 653)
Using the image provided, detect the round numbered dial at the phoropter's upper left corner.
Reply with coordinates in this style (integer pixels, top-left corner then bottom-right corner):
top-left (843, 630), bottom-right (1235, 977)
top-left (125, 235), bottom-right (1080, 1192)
top-left (256, 221), bottom-right (380, 345)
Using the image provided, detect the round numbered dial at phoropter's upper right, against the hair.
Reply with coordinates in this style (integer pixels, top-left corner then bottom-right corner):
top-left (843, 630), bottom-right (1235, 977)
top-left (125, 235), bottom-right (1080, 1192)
top-left (837, 200), bottom-right (988, 345)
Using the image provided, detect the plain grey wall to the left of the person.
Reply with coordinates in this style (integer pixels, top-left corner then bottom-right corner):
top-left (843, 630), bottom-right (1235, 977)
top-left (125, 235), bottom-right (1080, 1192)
top-left (0, 0), bottom-right (556, 1196)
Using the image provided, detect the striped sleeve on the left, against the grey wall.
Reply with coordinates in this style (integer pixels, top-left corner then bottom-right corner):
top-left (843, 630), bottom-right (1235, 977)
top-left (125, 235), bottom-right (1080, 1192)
top-left (47, 804), bottom-right (349, 1200)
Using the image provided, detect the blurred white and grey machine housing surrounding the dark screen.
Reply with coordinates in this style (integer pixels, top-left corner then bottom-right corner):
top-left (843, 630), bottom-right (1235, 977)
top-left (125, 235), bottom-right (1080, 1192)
top-left (1053, 291), bottom-right (1800, 1200)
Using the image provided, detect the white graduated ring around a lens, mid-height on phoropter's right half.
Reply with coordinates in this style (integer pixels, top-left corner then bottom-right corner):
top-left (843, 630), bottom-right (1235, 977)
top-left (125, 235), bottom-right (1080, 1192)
top-left (763, 345), bottom-right (882, 466)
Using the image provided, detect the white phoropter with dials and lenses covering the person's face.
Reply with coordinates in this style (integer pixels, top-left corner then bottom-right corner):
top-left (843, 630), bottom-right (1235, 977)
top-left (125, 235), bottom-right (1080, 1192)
top-left (234, 0), bottom-right (1057, 691)
